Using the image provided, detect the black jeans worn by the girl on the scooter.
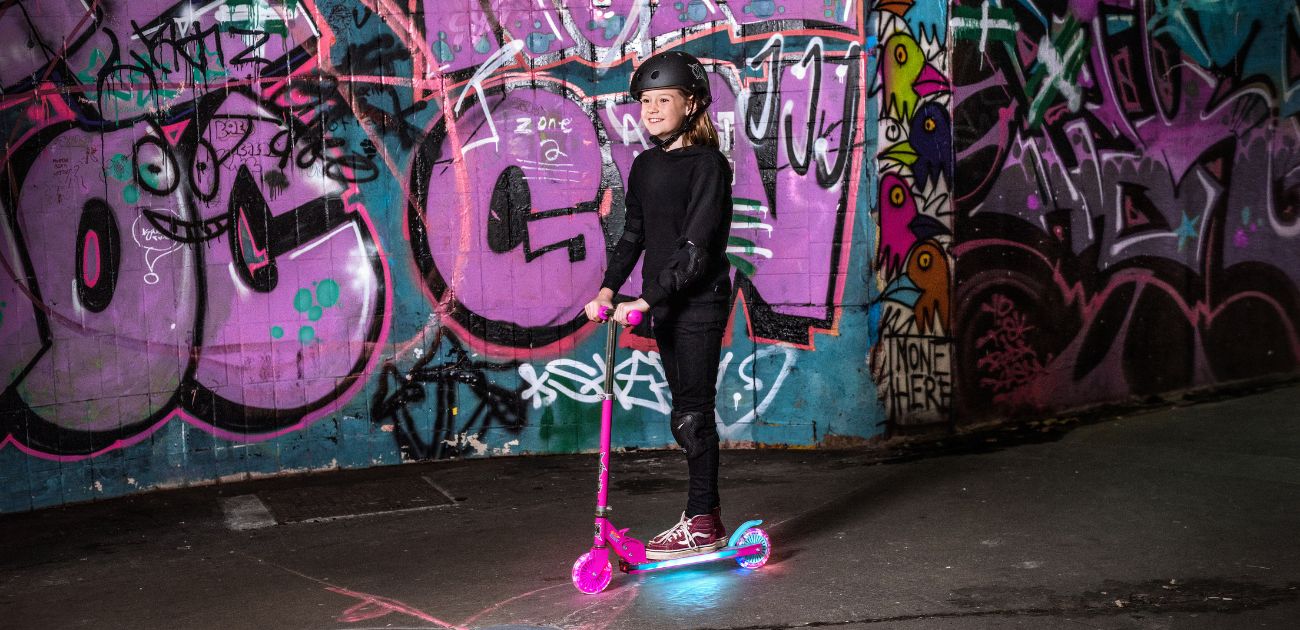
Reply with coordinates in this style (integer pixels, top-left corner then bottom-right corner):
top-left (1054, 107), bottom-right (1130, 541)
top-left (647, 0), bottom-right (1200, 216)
top-left (654, 311), bottom-right (727, 517)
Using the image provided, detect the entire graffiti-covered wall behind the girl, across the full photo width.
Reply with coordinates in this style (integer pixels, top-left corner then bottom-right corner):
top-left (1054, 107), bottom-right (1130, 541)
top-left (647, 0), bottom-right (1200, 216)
top-left (10, 0), bottom-right (1300, 512)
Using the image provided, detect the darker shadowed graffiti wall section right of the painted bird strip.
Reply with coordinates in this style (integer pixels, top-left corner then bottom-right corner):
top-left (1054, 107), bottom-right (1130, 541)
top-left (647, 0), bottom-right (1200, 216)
top-left (951, 0), bottom-right (1300, 420)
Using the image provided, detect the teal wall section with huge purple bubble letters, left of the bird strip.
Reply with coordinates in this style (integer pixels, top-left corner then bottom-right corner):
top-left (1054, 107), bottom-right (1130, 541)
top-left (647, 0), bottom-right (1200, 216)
top-left (0, 0), bottom-right (878, 512)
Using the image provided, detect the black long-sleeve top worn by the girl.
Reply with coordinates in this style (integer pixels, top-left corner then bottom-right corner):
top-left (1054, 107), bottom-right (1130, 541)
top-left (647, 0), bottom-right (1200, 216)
top-left (601, 144), bottom-right (732, 320)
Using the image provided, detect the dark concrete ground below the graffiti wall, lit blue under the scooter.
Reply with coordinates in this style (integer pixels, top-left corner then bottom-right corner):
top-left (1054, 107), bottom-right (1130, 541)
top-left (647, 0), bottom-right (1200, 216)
top-left (0, 384), bottom-right (1300, 630)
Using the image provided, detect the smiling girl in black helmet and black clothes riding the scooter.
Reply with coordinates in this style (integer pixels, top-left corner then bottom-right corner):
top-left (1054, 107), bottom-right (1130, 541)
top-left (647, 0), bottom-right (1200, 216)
top-left (585, 51), bottom-right (732, 560)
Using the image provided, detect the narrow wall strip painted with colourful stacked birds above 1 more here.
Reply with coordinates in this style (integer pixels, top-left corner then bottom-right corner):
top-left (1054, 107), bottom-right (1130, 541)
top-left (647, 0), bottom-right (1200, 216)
top-left (871, 0), bottom-right (954, 435)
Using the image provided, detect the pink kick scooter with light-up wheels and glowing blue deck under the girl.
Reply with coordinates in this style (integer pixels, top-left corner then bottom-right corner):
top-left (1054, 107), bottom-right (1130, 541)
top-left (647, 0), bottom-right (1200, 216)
top-left (572, 308), bottom-right (772, 595)
